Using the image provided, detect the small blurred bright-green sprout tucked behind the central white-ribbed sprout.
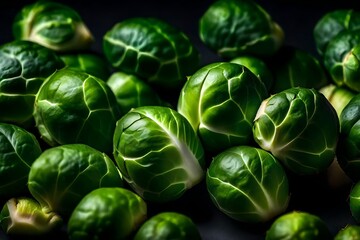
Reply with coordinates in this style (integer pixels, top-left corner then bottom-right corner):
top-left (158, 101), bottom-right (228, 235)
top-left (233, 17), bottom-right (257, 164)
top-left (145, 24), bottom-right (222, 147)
top-left (107, 71), bottom-right (163, 113)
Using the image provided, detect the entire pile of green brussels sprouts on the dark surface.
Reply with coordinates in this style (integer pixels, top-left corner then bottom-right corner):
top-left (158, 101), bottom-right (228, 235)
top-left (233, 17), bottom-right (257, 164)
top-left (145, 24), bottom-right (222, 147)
top-left (0, 0), bottom-right (360, 240)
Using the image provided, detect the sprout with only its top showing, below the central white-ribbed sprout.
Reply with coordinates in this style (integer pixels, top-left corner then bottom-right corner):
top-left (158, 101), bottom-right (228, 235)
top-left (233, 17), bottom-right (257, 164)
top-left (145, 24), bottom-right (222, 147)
top-left (134, 212), bottom-right (201, 240)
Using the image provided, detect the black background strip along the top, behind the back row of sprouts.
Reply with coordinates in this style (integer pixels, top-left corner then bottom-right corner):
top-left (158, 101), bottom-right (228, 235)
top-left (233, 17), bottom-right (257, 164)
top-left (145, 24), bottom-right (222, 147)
top-left (0, 0), bottom-right (359, 63)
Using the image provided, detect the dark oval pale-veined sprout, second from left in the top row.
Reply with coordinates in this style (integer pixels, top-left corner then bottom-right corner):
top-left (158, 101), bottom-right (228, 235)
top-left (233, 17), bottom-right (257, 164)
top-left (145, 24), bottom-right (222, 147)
top-left (103, 17), bottom-right (200, 89)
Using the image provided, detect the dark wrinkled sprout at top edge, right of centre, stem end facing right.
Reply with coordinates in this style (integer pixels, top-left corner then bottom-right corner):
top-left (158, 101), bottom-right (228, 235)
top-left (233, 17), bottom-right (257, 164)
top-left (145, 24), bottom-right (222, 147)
top-left (199, 0), bottom-right (284, 58)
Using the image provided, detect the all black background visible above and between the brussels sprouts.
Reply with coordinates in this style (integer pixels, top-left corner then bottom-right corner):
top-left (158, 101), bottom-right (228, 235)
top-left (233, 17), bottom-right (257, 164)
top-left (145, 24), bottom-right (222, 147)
top-left (0, 0), bottom-right (358, 240)
